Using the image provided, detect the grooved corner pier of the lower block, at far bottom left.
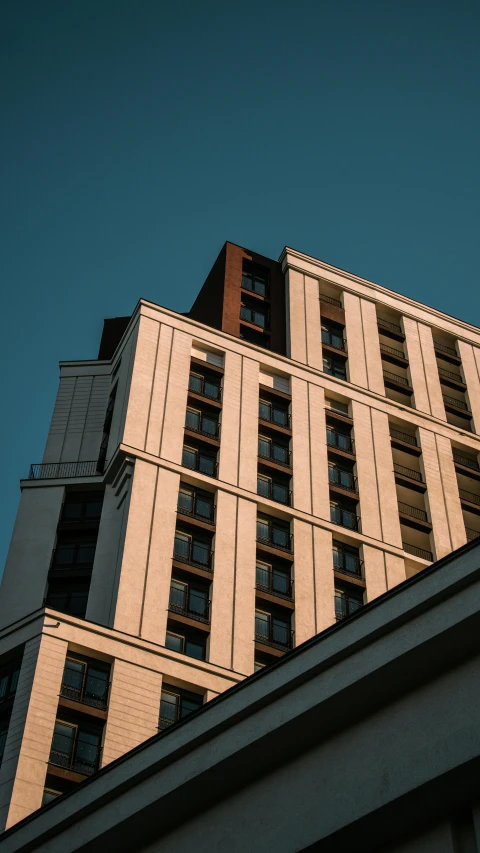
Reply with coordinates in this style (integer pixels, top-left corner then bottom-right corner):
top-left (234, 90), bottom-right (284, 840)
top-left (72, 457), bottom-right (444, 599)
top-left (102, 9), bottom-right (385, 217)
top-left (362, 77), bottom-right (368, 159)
top-left (0, 632), bottom-right (67, 829)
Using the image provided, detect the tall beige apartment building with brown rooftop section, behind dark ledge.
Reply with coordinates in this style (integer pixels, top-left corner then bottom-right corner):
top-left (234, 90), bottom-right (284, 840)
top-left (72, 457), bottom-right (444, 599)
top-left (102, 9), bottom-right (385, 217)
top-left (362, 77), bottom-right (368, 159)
top-left (0, 243), bottom-right (480, 827)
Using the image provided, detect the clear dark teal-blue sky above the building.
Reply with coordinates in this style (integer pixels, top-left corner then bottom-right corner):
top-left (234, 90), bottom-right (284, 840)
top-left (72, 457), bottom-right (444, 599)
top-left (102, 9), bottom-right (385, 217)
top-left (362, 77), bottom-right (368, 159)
top-left (0, 0), bottom-right (480, 565)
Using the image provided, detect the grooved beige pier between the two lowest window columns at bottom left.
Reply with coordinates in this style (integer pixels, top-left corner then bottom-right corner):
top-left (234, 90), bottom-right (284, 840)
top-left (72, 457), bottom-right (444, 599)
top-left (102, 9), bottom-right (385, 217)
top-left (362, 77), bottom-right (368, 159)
top-left (101, 658), bottom-right (162, 767)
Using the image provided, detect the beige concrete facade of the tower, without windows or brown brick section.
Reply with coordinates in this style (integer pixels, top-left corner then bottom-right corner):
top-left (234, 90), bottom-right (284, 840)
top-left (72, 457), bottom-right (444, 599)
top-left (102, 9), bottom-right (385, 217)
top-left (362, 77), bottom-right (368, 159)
top-left (0, 243), bottom-right (480, 826)
